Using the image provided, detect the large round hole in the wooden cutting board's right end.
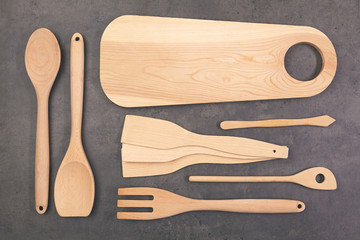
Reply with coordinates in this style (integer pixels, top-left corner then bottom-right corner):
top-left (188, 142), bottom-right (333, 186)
top-left (285, 43), bottom-right (322, 81)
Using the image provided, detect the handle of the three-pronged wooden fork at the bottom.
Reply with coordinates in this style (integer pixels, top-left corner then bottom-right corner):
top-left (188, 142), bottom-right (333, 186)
top-left (189, 199), bottom-right (305, 213)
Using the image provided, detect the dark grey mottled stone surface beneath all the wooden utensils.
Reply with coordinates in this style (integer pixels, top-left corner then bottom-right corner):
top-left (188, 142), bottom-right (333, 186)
top-left (0, 0), bottom-right (360, 239)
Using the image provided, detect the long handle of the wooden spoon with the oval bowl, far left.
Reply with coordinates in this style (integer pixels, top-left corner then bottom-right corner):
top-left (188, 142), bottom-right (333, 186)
top-left (35, 94), bottom-right (50, 214)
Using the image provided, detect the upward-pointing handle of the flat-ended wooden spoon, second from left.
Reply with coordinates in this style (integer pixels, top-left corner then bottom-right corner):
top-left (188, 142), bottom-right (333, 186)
top-left (70, 33), bottom-right (84, 143)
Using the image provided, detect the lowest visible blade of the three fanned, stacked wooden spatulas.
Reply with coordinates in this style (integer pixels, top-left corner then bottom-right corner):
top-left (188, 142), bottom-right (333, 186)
top-left (122, 154), bottom-right (274, 178)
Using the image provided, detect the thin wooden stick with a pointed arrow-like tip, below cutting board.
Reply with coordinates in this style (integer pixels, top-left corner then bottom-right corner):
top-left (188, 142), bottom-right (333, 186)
top-left (220, 115), bottom-right (336, 130)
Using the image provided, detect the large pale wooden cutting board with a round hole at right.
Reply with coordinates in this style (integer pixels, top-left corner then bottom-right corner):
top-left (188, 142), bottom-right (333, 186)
top-left (100, 16), bottom-right (337, 107)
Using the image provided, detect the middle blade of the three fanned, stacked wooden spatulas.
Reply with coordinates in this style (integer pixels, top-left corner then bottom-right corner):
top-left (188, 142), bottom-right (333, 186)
top-left (121, 143), bottom-right (270, 163)
